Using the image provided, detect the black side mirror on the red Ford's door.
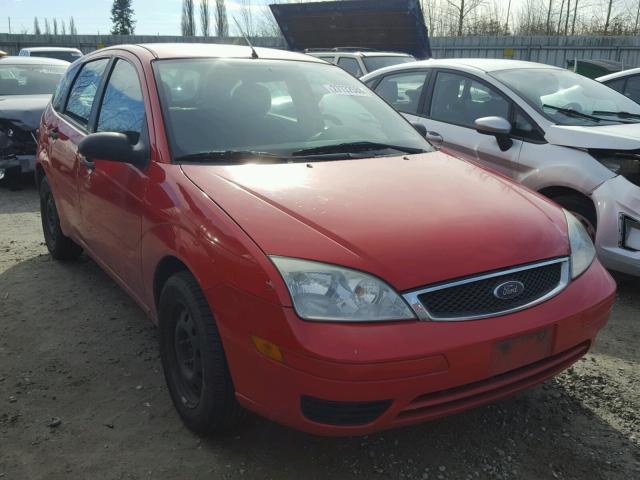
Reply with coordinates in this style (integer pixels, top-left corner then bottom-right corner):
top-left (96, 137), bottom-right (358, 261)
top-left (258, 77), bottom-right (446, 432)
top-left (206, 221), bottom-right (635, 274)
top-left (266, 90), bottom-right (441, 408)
top-left (78, 132), bottom-right (145, 165)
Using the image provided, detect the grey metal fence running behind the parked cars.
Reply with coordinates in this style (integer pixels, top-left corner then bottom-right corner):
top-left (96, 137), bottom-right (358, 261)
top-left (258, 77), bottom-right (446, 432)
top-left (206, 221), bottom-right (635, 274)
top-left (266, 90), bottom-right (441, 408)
top-left (0, 34), bottom-right (640, 68)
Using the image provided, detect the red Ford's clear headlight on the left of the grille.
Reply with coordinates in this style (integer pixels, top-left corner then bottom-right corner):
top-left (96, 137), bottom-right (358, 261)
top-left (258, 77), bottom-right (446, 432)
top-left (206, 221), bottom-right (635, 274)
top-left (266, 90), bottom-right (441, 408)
top-left (271, 257), bottom-right (416, 322)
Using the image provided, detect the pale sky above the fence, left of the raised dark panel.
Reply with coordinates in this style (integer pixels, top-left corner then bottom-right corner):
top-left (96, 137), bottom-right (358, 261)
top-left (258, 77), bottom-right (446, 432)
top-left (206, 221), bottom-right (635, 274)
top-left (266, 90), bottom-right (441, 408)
top-left (0, 0), bottom-right (278, 35)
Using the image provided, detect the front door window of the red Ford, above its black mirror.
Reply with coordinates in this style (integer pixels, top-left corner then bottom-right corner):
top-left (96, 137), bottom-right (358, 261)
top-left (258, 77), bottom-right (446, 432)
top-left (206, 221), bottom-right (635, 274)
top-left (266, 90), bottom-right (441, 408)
top-left (97, 60), bottom-right (144, 141)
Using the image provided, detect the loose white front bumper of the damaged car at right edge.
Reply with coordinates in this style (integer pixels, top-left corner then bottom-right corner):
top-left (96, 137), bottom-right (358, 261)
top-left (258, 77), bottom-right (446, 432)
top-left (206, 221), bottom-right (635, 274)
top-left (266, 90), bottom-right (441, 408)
top-left (591, 176), bottom-right (640, 276)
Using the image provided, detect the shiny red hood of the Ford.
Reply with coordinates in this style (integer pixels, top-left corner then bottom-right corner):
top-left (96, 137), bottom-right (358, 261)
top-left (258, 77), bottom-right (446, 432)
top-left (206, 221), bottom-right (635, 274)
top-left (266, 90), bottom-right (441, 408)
top-left (182, 152), bottom-right (569, 290)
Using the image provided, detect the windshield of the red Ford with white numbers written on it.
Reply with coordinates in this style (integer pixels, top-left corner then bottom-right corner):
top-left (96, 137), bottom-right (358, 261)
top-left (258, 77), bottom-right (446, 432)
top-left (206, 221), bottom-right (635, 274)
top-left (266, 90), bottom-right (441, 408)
top-left (154, 59), bottom-right (431, 161)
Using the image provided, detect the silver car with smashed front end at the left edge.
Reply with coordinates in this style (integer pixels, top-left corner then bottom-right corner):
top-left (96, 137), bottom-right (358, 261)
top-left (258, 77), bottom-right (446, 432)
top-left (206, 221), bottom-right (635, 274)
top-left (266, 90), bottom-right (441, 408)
top-left (0, 56), bottom-right (69, 183)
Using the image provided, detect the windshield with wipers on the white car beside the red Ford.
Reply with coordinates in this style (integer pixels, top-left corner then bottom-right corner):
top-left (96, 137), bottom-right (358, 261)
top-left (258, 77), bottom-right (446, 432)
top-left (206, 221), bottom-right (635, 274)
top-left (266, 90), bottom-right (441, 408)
top-left (492, 68), bottom-right (640, 125)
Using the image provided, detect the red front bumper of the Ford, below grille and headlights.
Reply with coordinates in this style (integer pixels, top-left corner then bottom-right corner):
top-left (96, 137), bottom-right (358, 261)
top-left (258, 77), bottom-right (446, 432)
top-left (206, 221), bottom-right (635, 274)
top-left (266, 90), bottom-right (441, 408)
top-left (207, 261), bottom-right (615, 436)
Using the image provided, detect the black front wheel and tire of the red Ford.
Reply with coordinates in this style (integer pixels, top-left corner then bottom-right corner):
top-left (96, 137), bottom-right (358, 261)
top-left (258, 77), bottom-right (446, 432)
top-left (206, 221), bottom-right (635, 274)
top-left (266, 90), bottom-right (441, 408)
top-left (158, 272), bottom-right (242, 435)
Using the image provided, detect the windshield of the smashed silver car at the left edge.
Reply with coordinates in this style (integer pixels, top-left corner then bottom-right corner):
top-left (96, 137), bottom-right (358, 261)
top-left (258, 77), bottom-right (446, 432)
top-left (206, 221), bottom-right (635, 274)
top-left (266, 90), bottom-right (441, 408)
top-left (0, 64), bottom-right (67, 95)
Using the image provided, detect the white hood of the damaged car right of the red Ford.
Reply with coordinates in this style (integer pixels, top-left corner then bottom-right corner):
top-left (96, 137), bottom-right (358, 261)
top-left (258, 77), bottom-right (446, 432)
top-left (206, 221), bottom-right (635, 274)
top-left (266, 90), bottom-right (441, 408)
top-left (544, 123), bottom-right (640, 150)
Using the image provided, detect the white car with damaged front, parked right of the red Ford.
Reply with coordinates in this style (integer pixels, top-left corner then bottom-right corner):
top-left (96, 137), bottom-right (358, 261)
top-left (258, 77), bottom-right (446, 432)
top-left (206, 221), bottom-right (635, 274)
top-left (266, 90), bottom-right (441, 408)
top-left (362, 59), bottom-right (640, 276)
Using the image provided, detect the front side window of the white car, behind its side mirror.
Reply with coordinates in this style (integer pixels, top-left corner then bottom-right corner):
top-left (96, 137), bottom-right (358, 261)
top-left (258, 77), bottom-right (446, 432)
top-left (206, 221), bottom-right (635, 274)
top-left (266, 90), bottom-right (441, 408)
top-left (431, 72), bottom-right (510, 127)
